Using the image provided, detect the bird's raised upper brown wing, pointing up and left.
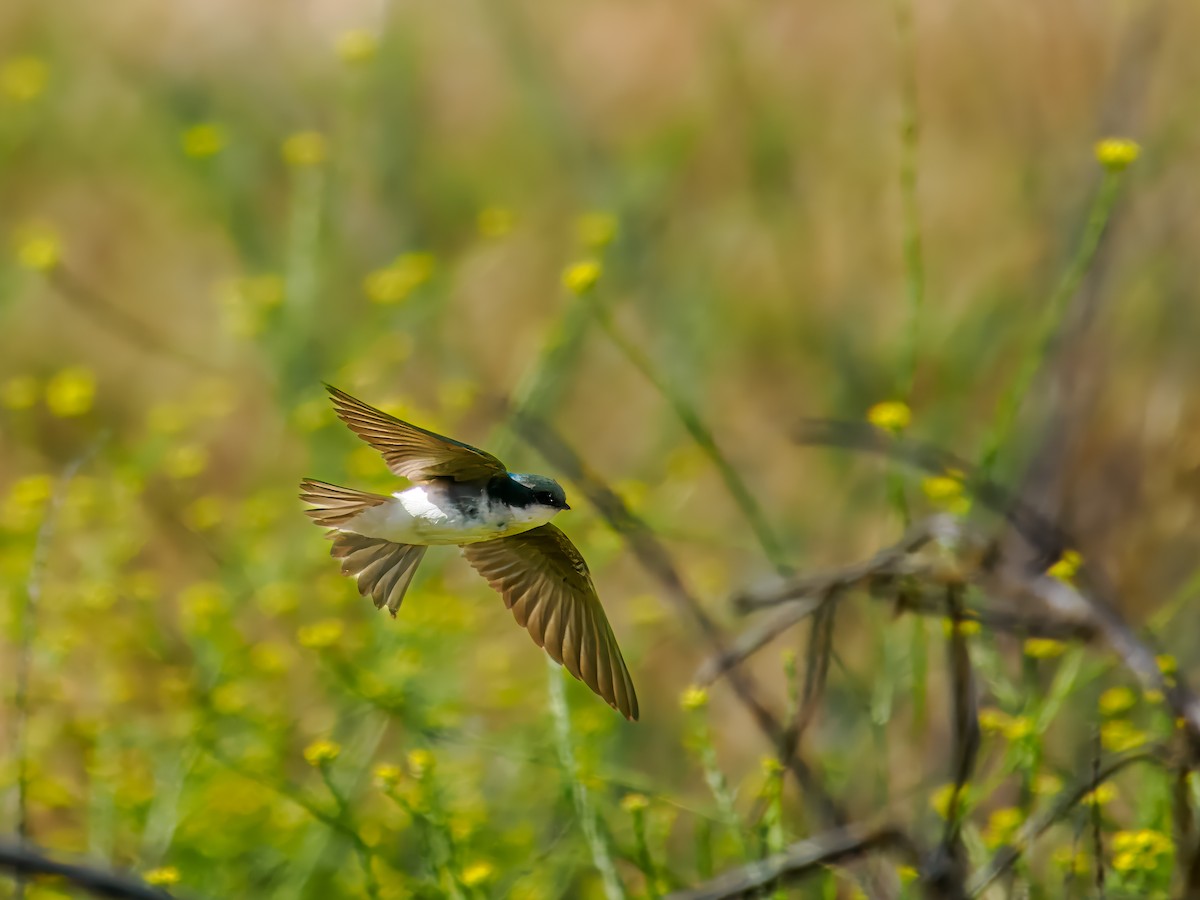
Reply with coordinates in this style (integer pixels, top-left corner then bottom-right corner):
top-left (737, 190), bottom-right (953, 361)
top-left (325, 384), bottom-right (508, 481)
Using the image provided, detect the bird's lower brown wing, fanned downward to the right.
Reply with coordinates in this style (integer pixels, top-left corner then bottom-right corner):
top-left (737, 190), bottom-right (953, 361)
top-left (462, 524), bottom-right (637, 720)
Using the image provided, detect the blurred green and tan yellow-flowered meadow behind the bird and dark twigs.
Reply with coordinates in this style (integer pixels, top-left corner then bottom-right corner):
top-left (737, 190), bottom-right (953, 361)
top-left (0, 0), bottom-right (1200, 898)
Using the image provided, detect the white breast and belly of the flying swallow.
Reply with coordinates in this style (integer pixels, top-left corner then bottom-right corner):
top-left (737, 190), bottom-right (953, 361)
top-left (341, 485), bottom-right (557, 544)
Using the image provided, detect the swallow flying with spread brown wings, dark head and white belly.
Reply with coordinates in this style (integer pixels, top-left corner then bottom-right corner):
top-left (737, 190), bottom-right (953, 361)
top-left (300, 385), bottom-right (637, 720)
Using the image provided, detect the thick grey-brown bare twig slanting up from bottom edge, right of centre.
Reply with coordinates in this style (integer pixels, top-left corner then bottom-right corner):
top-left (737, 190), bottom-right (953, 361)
top-left (667, 824), bottom-right (918, 900)
